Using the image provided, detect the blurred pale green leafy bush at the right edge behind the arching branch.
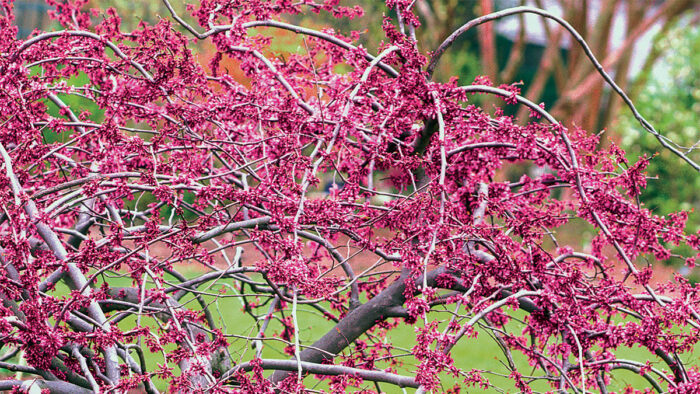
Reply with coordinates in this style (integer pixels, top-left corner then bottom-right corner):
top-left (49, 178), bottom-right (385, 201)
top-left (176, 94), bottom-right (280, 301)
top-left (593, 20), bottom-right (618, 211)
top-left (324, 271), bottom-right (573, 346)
top-left (615, 26), bottom-right (700, 232)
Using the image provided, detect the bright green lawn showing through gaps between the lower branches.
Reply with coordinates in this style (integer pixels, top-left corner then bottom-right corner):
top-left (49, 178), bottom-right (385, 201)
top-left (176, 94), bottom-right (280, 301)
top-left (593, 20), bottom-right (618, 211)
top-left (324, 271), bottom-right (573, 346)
top-left (0, 266), bottom-right (693, 393)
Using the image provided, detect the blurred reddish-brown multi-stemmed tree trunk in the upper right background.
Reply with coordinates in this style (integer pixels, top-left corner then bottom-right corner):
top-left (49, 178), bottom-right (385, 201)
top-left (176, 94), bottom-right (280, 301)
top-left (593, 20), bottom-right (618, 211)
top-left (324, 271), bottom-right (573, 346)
top-left (460, 0), bottom-right (700, 132)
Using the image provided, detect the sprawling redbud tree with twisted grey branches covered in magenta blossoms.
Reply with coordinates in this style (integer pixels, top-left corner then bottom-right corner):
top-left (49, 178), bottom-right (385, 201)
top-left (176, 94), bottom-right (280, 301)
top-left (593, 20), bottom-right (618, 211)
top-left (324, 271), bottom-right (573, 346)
top-left (0, 0), bottom-right (700, 393)
